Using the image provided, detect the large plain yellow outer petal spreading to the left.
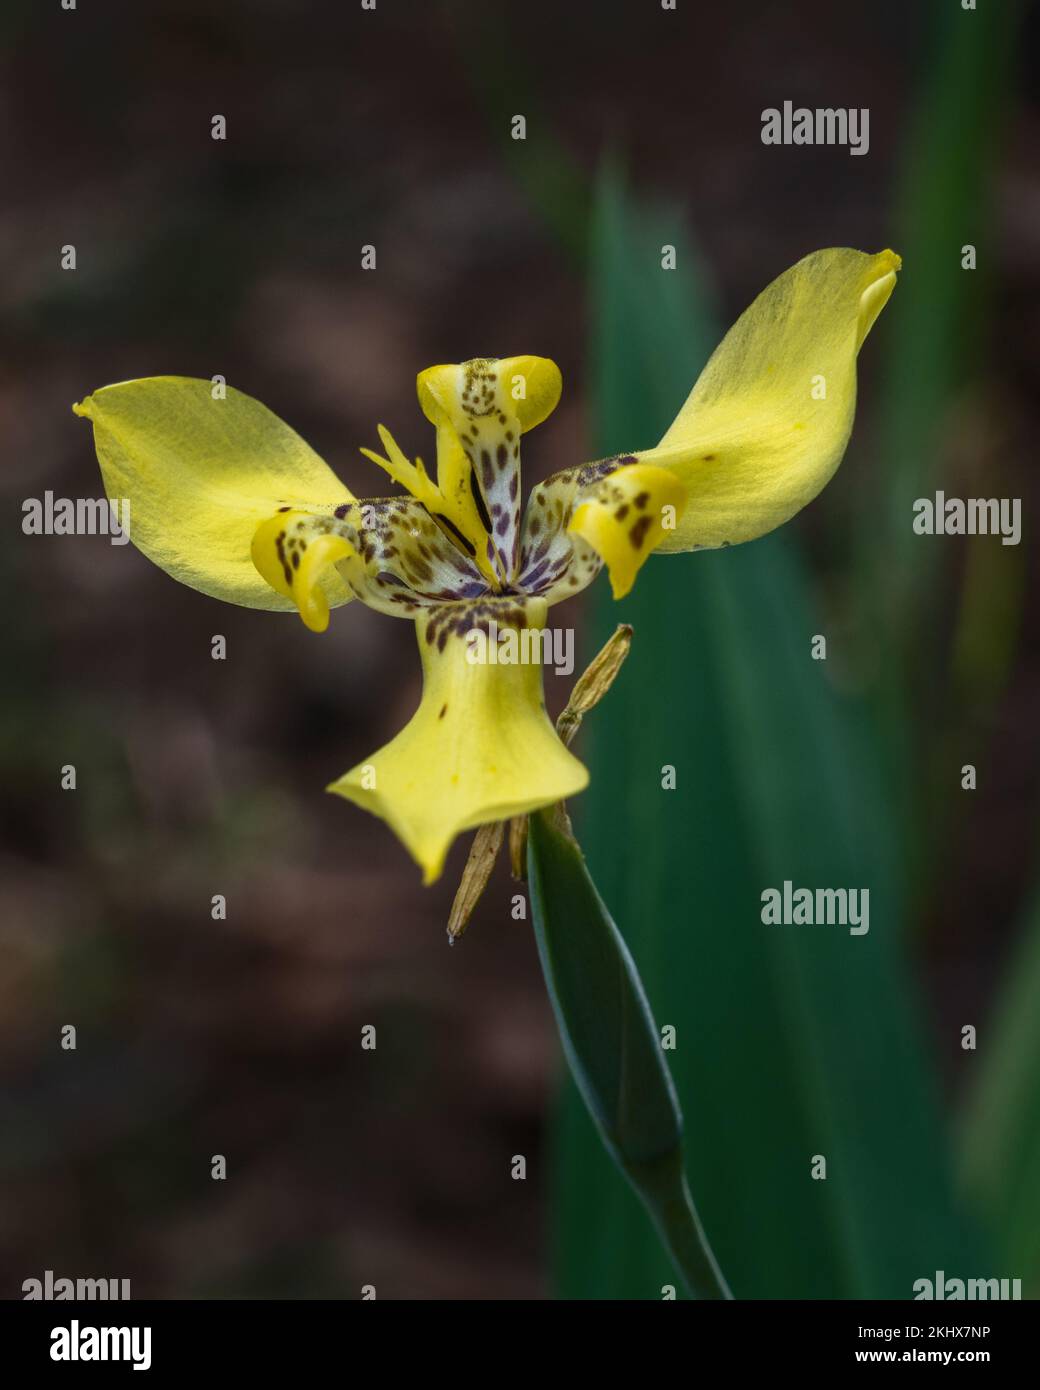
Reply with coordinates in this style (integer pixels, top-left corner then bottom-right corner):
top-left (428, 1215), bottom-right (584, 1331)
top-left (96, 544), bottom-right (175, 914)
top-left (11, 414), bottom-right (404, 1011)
top-left (72, 377), bottom-right (352, 610)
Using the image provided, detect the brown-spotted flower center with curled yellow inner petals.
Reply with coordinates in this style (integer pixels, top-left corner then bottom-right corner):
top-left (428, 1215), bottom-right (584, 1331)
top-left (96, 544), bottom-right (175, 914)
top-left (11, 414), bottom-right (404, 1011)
top-left (253, 357), bottom-right (684, 630)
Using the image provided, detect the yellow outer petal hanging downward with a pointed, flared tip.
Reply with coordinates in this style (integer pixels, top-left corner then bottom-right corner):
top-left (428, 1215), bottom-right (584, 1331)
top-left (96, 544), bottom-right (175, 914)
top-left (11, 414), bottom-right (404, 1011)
top-left (328, 599), bottom-right (588, 883)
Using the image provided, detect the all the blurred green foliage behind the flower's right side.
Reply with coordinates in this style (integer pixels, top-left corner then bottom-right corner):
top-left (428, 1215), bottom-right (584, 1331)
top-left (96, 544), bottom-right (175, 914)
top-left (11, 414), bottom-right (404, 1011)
top-left (545, 4), bottom-right (1040, 1298)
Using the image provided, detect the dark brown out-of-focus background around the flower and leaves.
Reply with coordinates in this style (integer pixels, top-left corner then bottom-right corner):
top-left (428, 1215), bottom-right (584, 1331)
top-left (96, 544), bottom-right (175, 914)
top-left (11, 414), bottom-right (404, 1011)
top-left (0, 0), bottom-right (1040, 1298)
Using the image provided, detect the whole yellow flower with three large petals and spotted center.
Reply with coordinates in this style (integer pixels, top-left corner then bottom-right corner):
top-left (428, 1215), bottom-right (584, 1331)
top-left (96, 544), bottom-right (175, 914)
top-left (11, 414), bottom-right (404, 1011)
top-left (72, 249), bottom-right (900, 883)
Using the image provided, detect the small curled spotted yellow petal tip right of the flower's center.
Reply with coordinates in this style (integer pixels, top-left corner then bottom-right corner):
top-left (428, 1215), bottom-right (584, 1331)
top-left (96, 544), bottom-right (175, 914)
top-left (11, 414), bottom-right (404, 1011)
top-left (567, 463), bottom-right (685, 599)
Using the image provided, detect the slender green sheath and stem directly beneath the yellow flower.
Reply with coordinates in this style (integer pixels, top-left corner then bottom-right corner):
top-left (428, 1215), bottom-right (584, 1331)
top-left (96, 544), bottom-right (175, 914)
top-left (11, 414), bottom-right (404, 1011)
top-left (527, 812), bottom-right (727, 1298)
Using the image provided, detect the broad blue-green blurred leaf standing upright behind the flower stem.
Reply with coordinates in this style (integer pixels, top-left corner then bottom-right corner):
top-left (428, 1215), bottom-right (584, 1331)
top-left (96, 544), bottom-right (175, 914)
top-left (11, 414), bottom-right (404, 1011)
top-left (555, 162), bottom-right (980, 1298)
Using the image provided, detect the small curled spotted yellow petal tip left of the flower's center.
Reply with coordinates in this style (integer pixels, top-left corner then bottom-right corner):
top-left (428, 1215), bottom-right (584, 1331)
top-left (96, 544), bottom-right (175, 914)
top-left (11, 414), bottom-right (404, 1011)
top-left (250, 510), bottom-right (361, 632)
